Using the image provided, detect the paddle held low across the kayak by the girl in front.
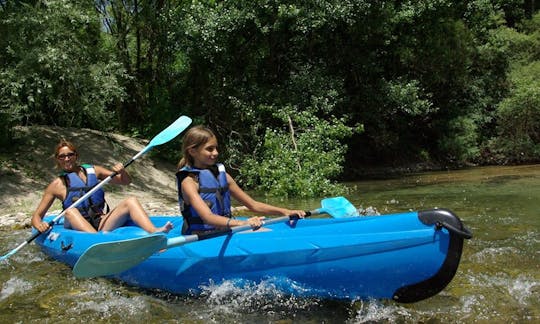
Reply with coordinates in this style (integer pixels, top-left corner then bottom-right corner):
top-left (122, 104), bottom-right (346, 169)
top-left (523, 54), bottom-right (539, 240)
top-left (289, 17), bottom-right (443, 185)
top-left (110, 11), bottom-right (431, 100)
top-left (73, 197), bottom-right (356, 278)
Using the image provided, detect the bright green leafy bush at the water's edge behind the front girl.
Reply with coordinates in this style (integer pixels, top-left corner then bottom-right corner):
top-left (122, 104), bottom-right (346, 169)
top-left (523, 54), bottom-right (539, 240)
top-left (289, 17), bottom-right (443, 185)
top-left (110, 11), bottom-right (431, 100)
top-left (240, 106), bottom-right (354, 197)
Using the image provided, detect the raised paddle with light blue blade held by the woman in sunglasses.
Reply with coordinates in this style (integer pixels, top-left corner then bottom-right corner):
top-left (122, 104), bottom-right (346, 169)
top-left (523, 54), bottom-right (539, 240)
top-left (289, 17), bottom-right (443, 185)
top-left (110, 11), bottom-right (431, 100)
top-left (0, 116), bottom-right (191, 260)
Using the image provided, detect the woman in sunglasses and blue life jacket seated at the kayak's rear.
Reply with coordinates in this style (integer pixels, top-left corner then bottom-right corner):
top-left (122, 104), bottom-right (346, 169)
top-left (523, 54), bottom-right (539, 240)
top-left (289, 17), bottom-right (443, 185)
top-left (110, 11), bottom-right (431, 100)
top-left (32, 140), bottom-right (173, 233)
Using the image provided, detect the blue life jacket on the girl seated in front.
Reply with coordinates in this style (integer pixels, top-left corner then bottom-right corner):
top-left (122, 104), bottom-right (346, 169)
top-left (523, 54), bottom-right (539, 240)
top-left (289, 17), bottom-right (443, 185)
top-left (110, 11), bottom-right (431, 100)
top-left (176, 163), bottom-right (231, 234)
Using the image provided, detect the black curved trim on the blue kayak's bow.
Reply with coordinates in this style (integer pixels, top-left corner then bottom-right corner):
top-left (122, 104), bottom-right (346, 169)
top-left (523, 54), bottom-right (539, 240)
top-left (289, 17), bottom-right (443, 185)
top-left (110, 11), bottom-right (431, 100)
top-left (392, 209), bottom-right (472, 303)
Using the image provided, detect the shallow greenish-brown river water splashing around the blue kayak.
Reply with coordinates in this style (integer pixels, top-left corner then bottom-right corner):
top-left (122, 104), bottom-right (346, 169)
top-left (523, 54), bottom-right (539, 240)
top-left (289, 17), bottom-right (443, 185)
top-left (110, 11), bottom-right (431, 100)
top-left (0, 165), bottom-right (540, 323)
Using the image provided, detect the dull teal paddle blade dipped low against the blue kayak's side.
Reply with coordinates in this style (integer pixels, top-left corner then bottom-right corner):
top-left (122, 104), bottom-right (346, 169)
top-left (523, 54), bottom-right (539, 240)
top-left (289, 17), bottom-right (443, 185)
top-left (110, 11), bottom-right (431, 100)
top-left (73, 234), bottom-right (167, 278)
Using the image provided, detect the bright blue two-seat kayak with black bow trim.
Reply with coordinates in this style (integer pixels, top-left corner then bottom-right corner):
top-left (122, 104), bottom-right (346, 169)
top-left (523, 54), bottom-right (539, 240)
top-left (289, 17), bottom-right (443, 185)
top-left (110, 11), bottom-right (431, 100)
top-left (36, 209), bottom-right (471, 303)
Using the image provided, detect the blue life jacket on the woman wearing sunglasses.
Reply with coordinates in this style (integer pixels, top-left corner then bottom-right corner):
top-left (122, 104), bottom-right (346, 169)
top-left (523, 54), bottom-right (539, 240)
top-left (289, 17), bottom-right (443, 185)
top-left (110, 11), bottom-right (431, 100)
top-left (60, 164), bottom-right (106, 220)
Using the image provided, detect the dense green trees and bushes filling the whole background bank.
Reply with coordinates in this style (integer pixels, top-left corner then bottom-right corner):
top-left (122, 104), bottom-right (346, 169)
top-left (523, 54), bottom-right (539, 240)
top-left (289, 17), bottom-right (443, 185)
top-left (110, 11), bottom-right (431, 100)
top-left (0, 0), bottom-right (540, 196)
